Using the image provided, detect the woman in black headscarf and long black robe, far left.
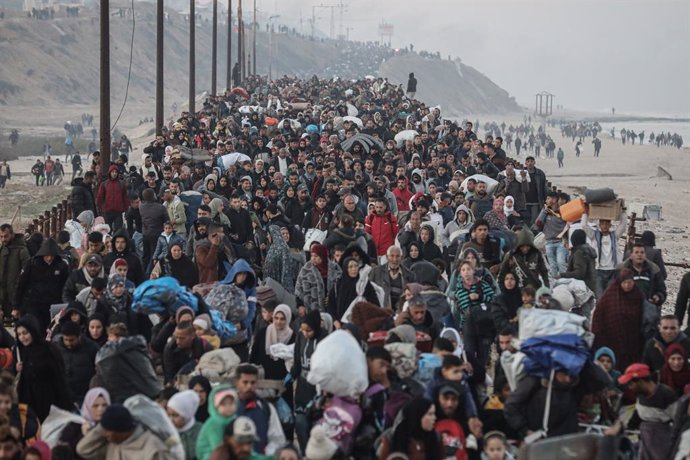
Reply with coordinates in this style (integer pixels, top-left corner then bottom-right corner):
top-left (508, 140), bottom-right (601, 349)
top-left (13, 315), bottom-right (72, 422)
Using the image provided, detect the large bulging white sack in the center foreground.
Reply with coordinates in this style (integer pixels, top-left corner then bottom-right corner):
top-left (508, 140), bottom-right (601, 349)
top-left (307, 331), bottom-right (369, 397)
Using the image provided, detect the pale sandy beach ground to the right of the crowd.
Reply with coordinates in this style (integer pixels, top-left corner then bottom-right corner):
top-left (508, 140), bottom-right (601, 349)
top-left (500, 122), bottom-right (690, 308)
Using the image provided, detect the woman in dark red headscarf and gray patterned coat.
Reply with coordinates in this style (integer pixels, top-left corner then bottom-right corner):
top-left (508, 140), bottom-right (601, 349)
top-left (295, 244), bottom-right (342, 310)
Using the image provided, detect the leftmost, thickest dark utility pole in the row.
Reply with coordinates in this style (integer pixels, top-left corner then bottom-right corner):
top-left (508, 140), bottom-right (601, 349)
top-left (100, 0), bottom-right (110, 176)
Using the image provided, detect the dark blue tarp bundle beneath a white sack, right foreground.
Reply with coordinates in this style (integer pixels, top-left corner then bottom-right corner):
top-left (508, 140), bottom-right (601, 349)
top-left (520, 334), bottom-right (591, 378)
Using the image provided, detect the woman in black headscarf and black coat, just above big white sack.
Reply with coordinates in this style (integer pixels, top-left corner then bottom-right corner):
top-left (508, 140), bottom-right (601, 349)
top-left (327, 257), bottom-right (380, 321)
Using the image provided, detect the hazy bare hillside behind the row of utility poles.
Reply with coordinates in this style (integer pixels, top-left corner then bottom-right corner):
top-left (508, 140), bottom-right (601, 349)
top-left (0, 3), bottom-right (518, 130)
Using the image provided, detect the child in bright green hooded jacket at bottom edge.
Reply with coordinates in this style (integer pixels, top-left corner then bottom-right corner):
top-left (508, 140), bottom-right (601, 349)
top-left (196, 384), bottom-right (238, 460)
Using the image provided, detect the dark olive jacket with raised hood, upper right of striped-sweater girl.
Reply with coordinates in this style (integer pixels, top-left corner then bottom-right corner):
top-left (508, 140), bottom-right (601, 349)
top-left (498, 227), bottom-right (549, 289)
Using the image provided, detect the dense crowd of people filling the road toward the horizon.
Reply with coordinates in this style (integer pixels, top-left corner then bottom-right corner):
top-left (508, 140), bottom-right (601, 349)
top-left (0, 73), bottom-right (690, 460)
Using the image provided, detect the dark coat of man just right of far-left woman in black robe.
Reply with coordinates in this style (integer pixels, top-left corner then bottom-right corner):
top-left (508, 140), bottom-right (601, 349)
top-left (57, 336), bottom-right (98, 404)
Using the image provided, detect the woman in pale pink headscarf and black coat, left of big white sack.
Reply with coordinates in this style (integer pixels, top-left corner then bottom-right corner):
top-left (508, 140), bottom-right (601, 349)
top-left (249, 304), bottom-right (295, 380)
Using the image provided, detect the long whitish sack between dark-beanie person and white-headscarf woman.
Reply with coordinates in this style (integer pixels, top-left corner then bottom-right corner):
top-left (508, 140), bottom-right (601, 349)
top-left (124, 395), bottom-right (185, 460)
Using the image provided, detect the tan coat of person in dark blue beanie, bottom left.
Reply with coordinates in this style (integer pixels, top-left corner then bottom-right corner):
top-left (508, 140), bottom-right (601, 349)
top-left (77, 424), bottom-right (176, 460)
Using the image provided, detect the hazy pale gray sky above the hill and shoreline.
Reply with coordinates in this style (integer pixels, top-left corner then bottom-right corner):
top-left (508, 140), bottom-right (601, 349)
top-left (254, 0), bottom-right (690, 116)
